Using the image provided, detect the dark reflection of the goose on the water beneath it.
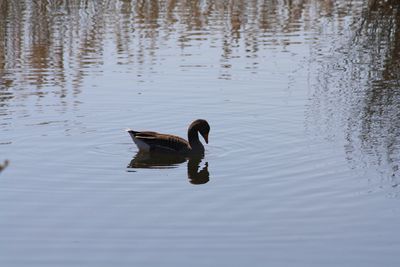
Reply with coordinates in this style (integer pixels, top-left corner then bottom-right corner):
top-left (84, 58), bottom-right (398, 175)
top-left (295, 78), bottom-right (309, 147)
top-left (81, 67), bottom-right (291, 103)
top-left (128, 152), bottom-right (210, 184)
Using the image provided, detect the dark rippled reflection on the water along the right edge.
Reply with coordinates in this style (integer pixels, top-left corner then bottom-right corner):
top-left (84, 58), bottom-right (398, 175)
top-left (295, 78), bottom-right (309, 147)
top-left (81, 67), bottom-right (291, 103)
top-left (313, 0), bottom-right (400, 182)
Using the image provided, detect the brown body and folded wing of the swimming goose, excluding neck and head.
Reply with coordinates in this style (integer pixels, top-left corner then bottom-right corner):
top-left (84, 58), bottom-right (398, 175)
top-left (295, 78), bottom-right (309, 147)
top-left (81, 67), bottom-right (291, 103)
top-left (128, 130), bottom-right (190, 152)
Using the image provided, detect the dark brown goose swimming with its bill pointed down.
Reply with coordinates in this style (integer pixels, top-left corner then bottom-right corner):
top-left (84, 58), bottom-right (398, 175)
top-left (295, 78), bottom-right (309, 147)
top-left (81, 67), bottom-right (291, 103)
top-left (126, 119), bottom-right (210, 155)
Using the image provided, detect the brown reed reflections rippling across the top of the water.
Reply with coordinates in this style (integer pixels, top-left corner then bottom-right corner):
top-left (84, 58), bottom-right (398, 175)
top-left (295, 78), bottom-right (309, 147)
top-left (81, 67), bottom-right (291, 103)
top-left (0, 0), bottom-right (360, 90)
